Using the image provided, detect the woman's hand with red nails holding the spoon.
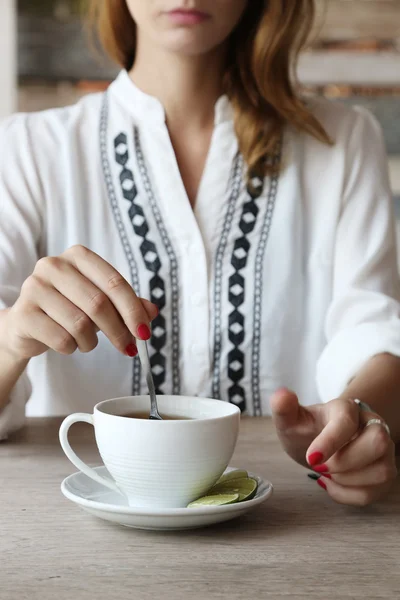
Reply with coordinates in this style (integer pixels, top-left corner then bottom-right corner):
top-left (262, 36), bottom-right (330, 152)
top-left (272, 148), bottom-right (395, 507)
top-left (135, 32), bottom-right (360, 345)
top-left (2, 246), bottom-right (158, 360)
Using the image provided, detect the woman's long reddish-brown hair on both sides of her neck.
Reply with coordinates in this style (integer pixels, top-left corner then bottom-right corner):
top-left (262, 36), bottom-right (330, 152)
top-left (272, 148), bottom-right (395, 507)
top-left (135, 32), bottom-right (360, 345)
top-left (90, 0), bottom-right (330, 176)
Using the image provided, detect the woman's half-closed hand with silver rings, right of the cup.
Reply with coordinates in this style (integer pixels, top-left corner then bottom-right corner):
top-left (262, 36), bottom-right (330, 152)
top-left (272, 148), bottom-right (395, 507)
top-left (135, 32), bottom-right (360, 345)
top-left (271, 390), bottom-right (397, 506)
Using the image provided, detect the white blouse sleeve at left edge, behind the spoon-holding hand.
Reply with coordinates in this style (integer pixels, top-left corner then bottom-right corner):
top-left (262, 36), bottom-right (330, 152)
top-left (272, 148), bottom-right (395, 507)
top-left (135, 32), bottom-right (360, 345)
top-left (0, 115), bottom-right (42, 440)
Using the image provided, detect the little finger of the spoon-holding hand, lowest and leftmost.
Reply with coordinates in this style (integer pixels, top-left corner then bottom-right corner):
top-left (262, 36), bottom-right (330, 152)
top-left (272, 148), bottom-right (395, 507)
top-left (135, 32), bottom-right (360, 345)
top-left (21, 309), bottom-right (77, 355)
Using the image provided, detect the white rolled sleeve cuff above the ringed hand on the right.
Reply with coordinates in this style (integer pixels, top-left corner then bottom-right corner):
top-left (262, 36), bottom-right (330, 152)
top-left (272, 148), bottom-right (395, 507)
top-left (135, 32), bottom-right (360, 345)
top-left (316, 320), bottom-right (400, 402)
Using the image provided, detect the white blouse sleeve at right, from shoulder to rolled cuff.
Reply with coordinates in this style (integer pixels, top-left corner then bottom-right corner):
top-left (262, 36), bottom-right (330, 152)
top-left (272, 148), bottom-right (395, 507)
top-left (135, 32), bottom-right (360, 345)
top-left (316, 109), bottom-right (400, 402)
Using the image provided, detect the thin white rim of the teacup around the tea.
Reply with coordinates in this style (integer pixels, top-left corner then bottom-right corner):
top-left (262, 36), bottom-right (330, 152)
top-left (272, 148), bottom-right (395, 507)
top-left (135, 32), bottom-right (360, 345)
top-left (93, 394), bottom-right (241, 426)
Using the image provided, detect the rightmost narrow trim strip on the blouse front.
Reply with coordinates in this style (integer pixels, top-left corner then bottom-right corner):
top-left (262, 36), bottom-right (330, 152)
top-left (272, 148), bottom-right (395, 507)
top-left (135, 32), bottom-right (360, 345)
top-left (251, 147), bottom-right (282, 417)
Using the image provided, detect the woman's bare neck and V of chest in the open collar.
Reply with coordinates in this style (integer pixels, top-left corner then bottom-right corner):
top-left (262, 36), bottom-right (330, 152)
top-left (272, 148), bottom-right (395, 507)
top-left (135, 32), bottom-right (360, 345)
top-left (130, 42), bottom-right (225, 206)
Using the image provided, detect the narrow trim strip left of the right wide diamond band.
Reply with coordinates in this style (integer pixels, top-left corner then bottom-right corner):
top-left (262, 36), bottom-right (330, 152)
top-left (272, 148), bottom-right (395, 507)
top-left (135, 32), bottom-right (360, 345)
top-left (211, 154), bottom-right (244, 399)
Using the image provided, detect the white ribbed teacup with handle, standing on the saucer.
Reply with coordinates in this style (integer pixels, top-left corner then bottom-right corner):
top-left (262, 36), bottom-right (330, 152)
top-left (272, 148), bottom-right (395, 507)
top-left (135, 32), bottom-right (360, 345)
top-left (60, 396), bottom-right (240, 508)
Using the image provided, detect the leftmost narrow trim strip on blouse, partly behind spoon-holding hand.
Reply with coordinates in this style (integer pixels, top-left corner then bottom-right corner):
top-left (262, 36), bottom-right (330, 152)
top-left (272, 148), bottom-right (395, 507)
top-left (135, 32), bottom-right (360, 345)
top-left (100, 92), bottom-right (141, 396)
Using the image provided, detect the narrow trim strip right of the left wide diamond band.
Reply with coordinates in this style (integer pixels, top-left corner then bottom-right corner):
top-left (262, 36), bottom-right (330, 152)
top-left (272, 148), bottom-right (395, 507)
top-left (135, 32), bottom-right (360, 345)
top-left (134, 127), bottom-right (181, 394)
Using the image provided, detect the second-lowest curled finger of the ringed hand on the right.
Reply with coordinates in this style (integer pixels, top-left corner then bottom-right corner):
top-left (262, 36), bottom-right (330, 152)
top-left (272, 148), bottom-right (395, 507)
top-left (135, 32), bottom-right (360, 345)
top-left (332, 455), bottom-right (397, 487)
